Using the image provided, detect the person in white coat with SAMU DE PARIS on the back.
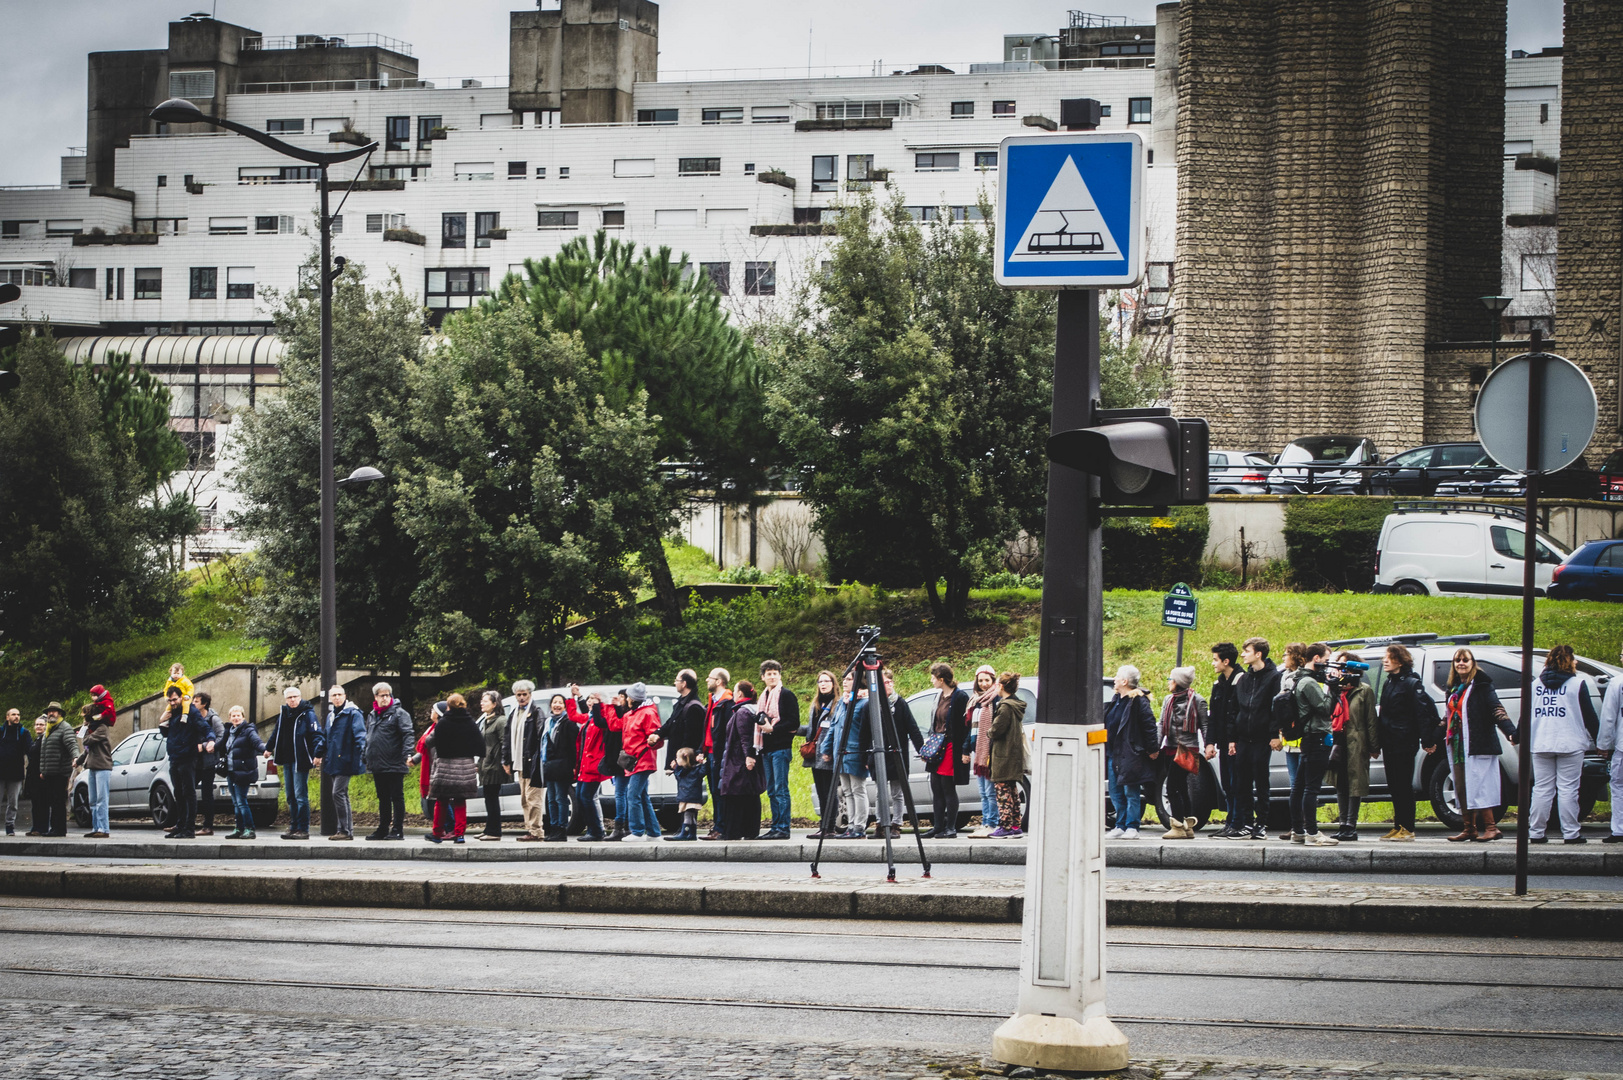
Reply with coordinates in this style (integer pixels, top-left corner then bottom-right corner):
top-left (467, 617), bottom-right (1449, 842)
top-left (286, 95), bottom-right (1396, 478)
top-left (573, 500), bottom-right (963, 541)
top-left (1522, 645), bottom-right (1600, 845)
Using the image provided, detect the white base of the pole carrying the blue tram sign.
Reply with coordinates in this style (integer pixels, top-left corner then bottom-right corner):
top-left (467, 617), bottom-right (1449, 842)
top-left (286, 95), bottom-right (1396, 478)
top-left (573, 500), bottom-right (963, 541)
top-left (992, 724), bottom-right (1128, 1072)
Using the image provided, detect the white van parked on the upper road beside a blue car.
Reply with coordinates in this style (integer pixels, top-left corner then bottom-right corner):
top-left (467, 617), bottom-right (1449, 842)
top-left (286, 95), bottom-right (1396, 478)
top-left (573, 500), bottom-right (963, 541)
top-left (1373, 502), bottom-right (1568, 596)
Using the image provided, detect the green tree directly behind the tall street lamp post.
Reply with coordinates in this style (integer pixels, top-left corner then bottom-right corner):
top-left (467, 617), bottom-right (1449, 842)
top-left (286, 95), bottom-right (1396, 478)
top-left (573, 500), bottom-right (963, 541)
top-left (230, 255), bottom-right (422, 676)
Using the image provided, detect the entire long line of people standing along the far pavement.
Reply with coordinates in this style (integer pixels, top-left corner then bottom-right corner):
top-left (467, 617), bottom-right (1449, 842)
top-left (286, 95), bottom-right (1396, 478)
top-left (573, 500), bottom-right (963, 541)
top-left (0, 637), bottom-right (1623, 846)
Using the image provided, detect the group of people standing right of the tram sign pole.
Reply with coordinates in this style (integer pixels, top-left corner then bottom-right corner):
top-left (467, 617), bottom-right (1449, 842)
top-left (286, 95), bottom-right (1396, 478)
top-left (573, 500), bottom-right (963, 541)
top-left (1105, 637), bottom-right (1623, 846)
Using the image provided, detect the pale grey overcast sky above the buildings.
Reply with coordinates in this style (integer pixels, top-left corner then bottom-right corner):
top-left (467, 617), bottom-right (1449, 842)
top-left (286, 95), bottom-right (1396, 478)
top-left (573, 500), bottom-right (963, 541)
top-left (0, 0), bottom-right (1561, 184)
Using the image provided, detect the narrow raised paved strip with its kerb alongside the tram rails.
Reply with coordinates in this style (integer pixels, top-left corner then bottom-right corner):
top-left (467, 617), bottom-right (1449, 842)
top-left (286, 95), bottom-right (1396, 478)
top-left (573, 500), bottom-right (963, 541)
top-left (0, 861), bottom-right (1623, 940)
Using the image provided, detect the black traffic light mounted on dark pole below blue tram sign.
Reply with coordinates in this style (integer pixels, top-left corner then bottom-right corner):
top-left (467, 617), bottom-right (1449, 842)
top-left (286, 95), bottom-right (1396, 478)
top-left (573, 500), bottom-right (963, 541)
top-left (1048, 409), bottom-right (1211, 507)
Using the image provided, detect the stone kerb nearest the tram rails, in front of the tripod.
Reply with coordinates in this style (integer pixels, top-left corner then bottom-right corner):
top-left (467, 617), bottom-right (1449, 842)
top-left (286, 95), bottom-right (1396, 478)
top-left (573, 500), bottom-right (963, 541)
top-left (0, 866), bottom-right (1623, 940)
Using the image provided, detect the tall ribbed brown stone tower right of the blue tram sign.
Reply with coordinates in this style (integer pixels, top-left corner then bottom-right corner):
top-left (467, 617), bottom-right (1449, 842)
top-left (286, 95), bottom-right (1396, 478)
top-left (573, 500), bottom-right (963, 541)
top-left (1173, 0), bottom-right (1505, 451)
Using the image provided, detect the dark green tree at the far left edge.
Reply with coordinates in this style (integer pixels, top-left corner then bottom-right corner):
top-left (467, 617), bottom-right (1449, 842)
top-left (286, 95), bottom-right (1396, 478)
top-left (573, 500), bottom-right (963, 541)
top-left (0, 326), bottom-right (183, 685)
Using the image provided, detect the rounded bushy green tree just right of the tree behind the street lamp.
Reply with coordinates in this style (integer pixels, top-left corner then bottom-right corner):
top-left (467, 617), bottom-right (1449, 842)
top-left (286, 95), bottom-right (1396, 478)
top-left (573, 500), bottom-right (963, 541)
top-left (383, 298), bottom-right (675, 676)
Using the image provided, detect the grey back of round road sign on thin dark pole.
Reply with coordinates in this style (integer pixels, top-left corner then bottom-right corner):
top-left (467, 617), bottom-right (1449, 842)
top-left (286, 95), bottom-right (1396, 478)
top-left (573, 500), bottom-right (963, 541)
top-left (1475, 352), bottom-right (1599, 473)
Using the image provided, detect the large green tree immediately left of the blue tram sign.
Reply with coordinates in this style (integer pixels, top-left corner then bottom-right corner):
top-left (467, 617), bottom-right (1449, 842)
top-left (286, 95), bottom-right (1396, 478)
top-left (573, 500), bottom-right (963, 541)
top-left (768, 192), bottom-right (1055, 619)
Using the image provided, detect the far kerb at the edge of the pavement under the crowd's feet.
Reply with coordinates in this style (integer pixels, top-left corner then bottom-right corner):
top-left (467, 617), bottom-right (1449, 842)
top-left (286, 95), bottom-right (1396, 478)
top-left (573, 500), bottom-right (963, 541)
top-left (0, 840), bottom-right (1623, 877)
